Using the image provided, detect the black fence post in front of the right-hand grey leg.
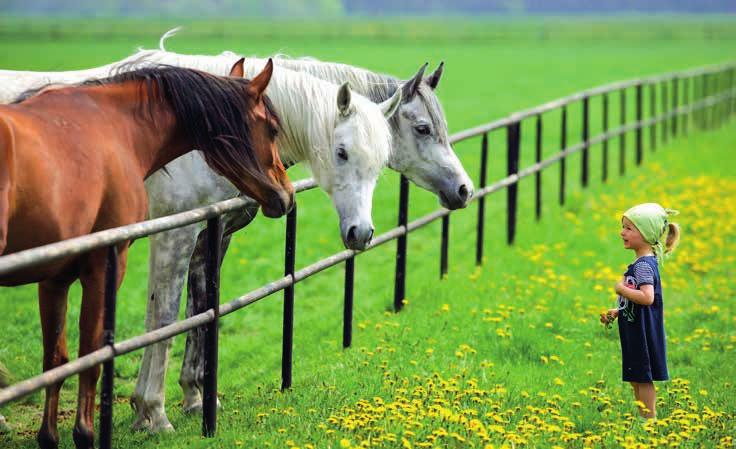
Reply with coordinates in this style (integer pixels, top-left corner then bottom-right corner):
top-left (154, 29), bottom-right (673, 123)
top-left (202, 216), bottom-right (222, 437)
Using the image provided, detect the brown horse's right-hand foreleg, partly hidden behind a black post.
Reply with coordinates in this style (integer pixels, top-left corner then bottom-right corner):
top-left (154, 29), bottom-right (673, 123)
top-left (72, 246), bottom-right (128, 449)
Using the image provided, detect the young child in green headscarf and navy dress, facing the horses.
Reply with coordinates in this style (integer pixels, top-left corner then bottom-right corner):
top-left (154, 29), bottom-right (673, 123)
top-left (600, 203), bottom-right (680, 419)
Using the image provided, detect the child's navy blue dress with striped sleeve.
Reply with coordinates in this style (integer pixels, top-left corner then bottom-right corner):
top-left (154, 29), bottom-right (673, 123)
top-left (618, 256), bottom-right (669, 383)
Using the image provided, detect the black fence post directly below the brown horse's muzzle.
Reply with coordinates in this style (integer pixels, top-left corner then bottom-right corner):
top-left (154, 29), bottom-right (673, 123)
top-left (281, 204), bottom-right (297, 391)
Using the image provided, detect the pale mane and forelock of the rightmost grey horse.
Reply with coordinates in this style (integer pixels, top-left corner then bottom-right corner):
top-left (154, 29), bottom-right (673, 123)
top-left (268, 54), bottom-right (449, 144)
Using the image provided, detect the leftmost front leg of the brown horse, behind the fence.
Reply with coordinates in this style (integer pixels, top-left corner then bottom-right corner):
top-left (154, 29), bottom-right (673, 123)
top-left (37, 281), bottom-right (70, 449)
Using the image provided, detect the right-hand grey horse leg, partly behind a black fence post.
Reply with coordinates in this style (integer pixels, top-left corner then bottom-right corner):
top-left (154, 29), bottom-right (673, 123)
top-left (179, 224), bottom-right (236, 413)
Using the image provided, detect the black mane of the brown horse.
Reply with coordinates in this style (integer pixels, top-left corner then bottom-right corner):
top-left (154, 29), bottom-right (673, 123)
top-left (85, 65), bottom-right (280, 184)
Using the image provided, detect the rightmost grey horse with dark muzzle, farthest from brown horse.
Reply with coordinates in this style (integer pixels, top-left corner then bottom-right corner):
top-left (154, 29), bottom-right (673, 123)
top-left (133, 39), bottom-right (473, 431)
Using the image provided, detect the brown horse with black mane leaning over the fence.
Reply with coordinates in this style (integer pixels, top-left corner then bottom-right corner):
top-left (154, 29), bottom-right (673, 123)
top-left (0, 60), bottom-right (294, 448)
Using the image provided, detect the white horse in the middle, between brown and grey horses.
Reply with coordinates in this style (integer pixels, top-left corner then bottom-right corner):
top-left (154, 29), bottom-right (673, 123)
top-left (2, 52), bottom-right (401, 431)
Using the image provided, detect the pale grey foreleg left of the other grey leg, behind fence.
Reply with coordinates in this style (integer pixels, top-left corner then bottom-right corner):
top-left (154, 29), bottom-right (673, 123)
top-left (131, 225), bottom-right (198, 432)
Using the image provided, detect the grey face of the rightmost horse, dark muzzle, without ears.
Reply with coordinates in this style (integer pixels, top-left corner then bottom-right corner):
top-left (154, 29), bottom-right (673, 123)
top-left (389, 91), bottom-right (473, 209)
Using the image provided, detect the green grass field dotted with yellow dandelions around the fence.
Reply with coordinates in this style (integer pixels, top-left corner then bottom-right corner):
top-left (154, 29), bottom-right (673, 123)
top-left (0, 18), bottom-right (736, 448)
